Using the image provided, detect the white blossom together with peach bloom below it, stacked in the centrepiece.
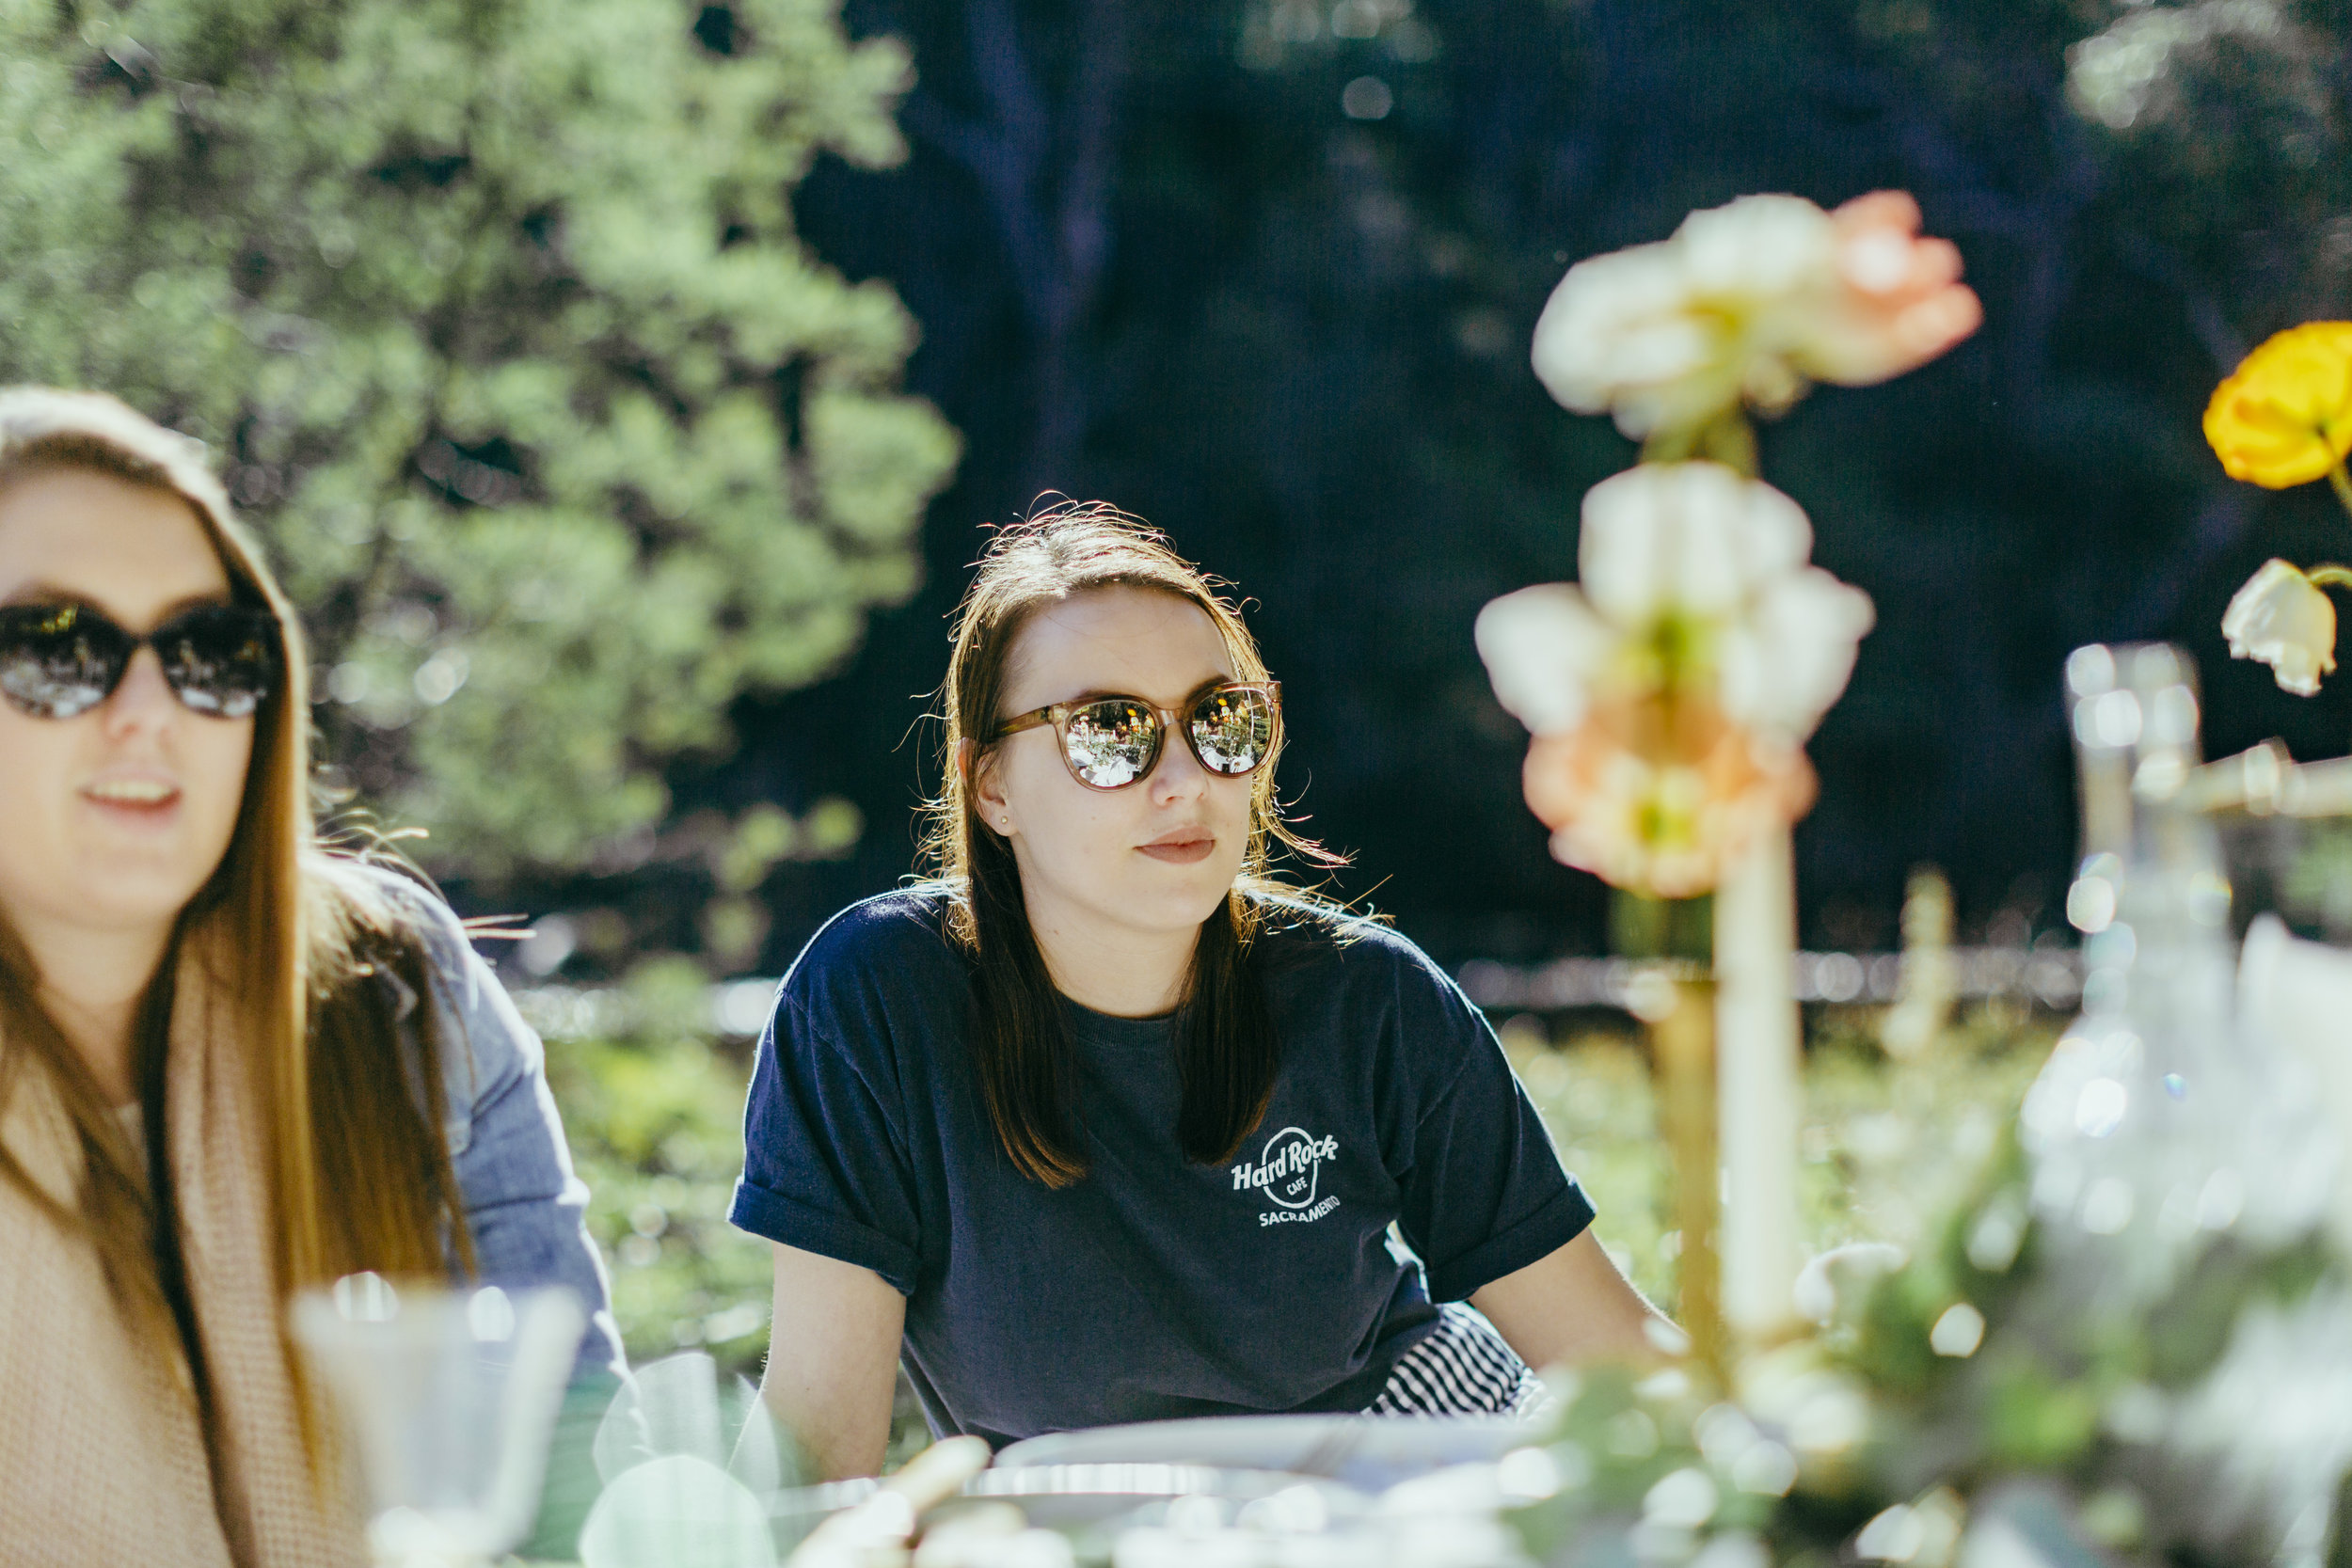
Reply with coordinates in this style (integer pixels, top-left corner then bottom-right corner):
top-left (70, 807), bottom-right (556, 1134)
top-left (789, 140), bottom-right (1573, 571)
top-left (1477, 463), bottom-right (1870, 898)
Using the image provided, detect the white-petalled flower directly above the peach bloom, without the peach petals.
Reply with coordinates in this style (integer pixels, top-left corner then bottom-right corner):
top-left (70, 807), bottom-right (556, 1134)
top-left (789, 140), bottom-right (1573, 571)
top-left (1477, 463), bottom-right (1872, 740)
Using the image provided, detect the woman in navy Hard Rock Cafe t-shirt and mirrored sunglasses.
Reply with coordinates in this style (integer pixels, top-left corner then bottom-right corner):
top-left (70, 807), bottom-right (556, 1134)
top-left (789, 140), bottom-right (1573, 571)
top-left (734, 505), bottom-right (1673, 1477)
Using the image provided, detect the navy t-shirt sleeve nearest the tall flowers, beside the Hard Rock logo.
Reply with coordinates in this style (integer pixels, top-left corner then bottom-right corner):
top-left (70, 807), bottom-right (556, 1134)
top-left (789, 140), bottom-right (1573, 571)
top-left (1397, 974), bottom-right (1593, 1303)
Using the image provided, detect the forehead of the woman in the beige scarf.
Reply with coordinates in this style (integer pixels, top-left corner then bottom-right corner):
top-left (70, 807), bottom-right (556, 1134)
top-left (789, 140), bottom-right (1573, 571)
top-left (0, 467), bottom-right (230, 626)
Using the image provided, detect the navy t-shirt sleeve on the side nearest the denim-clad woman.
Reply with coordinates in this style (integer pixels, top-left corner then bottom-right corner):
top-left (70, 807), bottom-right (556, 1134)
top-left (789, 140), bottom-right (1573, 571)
top-left (727, 983), bottom-right (922, 1295)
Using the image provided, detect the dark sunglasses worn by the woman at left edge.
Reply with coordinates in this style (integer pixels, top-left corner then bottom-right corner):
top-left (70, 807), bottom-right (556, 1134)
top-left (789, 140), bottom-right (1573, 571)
top-left (0, 604), bottom-right (278, 720)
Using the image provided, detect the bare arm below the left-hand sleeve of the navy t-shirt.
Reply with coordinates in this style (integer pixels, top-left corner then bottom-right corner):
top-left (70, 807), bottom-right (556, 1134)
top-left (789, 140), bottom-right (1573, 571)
top-left (760, 1242), bottom-right (906, 1481)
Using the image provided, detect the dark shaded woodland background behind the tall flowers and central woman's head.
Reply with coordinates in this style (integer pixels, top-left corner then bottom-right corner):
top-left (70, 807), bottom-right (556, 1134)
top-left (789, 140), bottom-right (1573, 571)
top-left (675, 0), bottom-right (2352, 971)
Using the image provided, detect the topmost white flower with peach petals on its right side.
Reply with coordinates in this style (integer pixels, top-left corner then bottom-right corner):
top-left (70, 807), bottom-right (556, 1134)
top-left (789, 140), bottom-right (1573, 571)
top-left (1534, 190), bottom-right (1983, 437)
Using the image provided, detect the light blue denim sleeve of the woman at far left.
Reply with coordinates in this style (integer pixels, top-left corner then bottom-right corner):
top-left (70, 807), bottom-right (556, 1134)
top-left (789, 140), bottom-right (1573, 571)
top-left (370, 870), bottom-right (628, 1378)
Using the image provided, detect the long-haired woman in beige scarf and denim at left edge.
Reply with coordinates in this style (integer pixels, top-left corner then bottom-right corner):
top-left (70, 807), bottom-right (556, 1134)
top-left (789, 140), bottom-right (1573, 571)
top-left (0, 388), bottom-right (619, 1568)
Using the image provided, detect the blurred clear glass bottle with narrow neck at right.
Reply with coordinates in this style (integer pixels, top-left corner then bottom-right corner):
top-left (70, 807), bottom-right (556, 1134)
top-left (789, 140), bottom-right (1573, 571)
top-left (2023, 644), bottom-right (2336, 1305)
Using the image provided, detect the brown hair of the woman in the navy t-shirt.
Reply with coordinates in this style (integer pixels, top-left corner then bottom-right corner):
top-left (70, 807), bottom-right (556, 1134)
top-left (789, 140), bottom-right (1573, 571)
top-left (925, 500), bottom-right (1343, 1187)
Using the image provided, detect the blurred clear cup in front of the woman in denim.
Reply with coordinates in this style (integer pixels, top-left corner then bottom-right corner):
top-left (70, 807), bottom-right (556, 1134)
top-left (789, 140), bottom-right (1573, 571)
top-left (294, 1275), bottom-right (586, 1568)
